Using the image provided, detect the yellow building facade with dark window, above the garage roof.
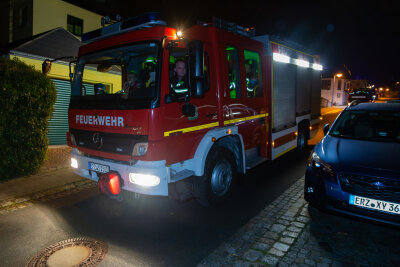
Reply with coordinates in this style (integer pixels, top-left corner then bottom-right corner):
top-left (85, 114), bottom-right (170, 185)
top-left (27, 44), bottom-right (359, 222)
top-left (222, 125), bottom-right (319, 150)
top-left (0, 0), bottom-right (102, 45)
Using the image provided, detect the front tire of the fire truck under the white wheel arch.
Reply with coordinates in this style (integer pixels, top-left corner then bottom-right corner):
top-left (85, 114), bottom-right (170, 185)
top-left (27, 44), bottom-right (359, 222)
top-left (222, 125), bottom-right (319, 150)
top-left (194, 147), bottom-right (237, 207)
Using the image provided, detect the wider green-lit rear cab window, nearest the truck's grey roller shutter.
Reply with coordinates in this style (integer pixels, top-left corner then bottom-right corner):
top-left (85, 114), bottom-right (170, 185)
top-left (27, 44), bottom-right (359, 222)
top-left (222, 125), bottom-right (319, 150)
top-left (244, 50), bottom-right (263, 98)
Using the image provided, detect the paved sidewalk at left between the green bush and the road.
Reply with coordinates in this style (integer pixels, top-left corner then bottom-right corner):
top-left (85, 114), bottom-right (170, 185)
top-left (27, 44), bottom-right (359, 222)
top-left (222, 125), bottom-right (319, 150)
top-left (0, 147), bottom-right (95, 214)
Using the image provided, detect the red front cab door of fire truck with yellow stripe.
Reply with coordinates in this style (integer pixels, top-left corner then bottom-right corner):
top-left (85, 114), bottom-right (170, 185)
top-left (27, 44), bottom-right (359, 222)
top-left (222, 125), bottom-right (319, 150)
top-left (162, 43), bottom-right (218, 164)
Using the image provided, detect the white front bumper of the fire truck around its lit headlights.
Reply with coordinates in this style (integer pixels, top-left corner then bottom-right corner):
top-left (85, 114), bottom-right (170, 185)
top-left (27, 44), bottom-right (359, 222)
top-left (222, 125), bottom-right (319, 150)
top-left (71, 150), bottom-right (170, 196)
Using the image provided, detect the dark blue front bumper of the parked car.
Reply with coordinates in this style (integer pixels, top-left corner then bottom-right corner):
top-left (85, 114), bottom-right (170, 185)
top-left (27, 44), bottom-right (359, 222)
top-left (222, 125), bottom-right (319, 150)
top-left (304, 167), bottom-right (400, 227)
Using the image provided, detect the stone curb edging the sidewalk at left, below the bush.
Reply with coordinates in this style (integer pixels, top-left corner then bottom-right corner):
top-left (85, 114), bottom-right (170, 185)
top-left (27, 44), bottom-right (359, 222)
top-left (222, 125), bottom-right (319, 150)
top-left (0, 179), bottom-right (97, 215)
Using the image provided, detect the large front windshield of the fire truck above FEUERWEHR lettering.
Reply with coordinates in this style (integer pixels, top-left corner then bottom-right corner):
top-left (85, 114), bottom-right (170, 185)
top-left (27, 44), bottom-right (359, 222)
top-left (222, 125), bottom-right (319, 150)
top-left (72, 42), bottom-right (158, 100)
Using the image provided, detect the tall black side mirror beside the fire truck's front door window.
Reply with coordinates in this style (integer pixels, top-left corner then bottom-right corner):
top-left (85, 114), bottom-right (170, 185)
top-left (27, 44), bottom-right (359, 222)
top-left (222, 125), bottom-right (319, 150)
top-left (188, 40), bottom-right (205, 98)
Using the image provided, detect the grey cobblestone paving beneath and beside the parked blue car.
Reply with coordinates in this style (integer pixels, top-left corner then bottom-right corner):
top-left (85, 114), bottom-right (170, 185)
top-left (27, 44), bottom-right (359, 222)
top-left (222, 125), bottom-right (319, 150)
top-left (198, 177), bottom-right (400, 267)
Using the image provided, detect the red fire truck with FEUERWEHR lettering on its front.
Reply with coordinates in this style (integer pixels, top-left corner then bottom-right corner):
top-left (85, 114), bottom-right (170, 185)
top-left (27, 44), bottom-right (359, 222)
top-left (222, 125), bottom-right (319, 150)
top-left (67, 14), bottom-right (322, 205)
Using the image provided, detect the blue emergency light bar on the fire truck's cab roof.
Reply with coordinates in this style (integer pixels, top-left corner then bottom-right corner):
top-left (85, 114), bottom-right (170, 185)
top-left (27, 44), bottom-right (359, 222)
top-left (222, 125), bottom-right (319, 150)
top-left (82, 12), bottom-right (166, 43)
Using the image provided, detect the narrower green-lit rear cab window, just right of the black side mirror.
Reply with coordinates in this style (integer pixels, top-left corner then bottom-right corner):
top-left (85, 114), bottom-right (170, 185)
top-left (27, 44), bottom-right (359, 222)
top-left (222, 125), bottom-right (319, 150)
top-left (226, 46), bottom-right (241, 99)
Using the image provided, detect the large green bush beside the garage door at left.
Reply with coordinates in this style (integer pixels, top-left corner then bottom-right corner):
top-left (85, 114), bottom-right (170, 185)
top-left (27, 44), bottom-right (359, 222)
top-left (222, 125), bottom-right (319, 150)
top-left (0, 58), bottom-right (57, 180)
